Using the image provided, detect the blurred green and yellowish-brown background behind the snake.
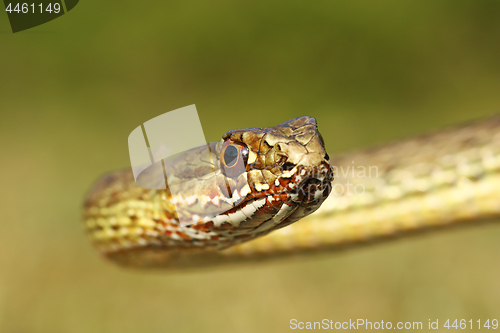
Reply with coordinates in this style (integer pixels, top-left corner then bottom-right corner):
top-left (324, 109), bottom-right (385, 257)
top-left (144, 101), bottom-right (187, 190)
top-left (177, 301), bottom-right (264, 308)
top-left (0, 0), bottom-right (500, 333)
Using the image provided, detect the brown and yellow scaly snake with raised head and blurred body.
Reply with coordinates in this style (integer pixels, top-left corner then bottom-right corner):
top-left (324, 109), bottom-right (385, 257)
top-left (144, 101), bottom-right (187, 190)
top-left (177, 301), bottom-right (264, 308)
top-left (83, 116), bottom-right (500, 269)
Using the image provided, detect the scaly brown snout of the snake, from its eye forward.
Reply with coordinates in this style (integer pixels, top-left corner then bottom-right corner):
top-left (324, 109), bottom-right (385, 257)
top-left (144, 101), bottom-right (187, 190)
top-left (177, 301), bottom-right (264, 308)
top-left (220, 117), bottom-right (333, 235)
